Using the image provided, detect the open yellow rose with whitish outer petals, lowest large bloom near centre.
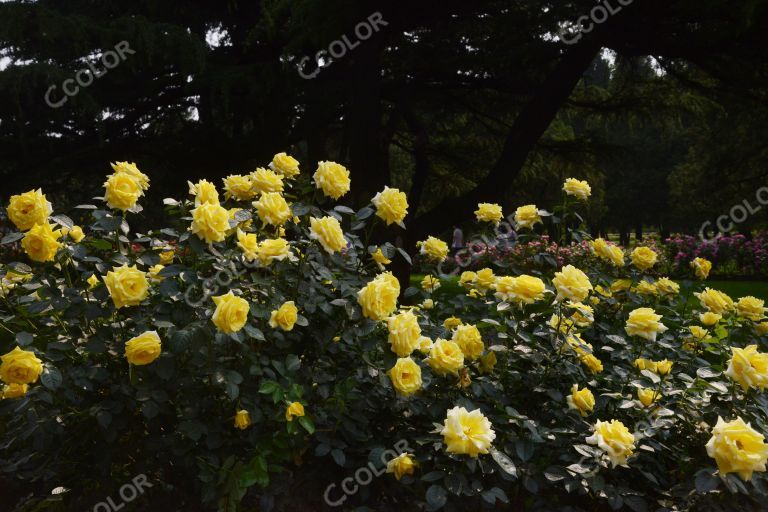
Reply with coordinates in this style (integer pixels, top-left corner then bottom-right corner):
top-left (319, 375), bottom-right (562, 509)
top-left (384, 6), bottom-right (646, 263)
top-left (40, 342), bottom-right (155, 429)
top-left (440, 406), bottom-right (496, 458)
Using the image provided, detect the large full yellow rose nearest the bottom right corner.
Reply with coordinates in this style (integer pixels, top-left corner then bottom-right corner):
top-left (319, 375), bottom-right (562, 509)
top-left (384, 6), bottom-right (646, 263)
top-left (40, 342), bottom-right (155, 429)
top-left (706, 416), bottom-right (768, 481)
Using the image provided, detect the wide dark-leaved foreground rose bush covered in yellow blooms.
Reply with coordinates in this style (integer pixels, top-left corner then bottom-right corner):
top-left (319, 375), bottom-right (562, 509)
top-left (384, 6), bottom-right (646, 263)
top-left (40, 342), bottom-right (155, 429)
top-left (0, 165), bottom-right (768, 511)
